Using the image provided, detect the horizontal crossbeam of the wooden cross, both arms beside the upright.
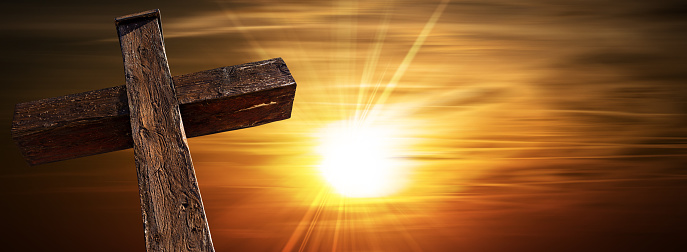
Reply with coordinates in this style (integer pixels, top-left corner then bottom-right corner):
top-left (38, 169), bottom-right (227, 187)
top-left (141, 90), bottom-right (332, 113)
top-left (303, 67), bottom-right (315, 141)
top-left (12, 54), bottom-right (296, 165)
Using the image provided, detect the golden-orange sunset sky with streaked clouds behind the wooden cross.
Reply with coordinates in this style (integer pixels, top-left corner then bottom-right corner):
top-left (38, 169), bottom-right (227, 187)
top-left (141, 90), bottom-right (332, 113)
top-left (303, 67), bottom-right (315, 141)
top-left (0, 0), bottom-right (687, 252)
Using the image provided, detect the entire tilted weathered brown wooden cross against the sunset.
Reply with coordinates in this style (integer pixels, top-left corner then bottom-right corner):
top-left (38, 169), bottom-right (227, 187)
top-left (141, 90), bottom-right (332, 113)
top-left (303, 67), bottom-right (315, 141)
top-left (12, 10), bottom-right (296, 251)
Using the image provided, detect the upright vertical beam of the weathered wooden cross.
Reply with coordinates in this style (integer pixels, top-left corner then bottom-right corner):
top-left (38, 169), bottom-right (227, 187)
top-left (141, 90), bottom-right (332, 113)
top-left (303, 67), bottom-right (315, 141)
top-left (116, 10), bottom-right (214, 251)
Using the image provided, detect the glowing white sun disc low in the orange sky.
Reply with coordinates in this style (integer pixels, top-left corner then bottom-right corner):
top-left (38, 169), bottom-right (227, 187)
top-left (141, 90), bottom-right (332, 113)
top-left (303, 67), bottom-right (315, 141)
top-left (318, 122), bottom-right (403, 198)
